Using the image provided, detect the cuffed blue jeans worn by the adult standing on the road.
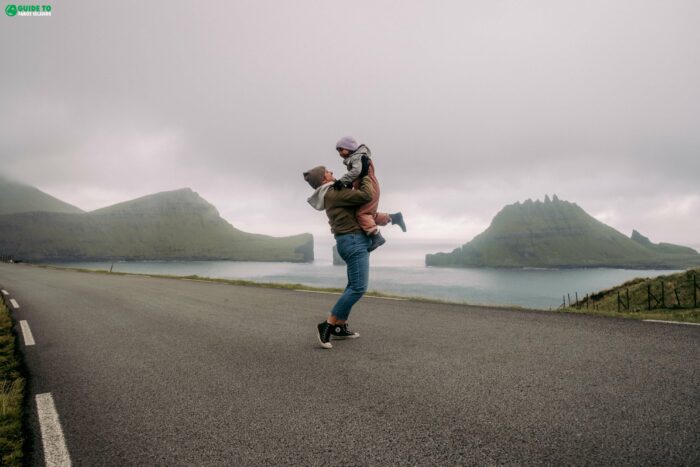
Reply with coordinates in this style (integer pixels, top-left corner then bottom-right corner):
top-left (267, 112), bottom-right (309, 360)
top-left (331, 232), bottom-right (371, 320)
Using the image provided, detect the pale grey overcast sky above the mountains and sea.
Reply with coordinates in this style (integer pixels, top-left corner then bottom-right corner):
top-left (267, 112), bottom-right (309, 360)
top-left (0, 0), bottom-right (700, 262)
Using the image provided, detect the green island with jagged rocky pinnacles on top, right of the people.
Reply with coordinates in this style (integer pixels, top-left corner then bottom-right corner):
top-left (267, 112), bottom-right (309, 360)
top-left (426, 195), bottom-right (700, 269)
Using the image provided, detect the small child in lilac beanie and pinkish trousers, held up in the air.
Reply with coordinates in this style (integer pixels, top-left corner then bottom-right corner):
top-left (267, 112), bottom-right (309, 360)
top-left (334, 136), bottom-right (406, 251)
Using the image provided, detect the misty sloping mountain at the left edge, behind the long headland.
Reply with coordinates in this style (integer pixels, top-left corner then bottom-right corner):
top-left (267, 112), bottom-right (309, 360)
top-left (0, 175), bottom-right (83, 215)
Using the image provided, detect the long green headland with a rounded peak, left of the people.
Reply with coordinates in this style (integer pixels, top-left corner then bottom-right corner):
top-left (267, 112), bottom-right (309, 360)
top-left (0, 188), bottom-right (313, 262)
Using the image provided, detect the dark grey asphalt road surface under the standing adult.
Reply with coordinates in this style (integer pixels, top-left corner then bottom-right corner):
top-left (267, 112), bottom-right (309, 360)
top-left (0, 264), bottom-right (700, 465)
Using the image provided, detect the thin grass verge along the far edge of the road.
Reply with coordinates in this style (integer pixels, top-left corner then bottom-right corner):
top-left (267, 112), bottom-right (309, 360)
top-left (37, 265), bottom-right (700, 323)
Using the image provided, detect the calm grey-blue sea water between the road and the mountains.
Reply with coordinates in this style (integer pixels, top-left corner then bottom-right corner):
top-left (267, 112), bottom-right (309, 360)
top-left (45, 261), bottom-right (677, 309)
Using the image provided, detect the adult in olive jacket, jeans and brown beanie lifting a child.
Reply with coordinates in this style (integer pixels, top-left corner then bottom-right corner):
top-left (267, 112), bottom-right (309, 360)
top-left (304, 159), bottom-right (375, 349)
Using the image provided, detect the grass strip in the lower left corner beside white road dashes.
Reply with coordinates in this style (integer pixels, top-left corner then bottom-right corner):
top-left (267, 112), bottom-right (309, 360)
top-left (0, 300), bottom-right (25, 466)
